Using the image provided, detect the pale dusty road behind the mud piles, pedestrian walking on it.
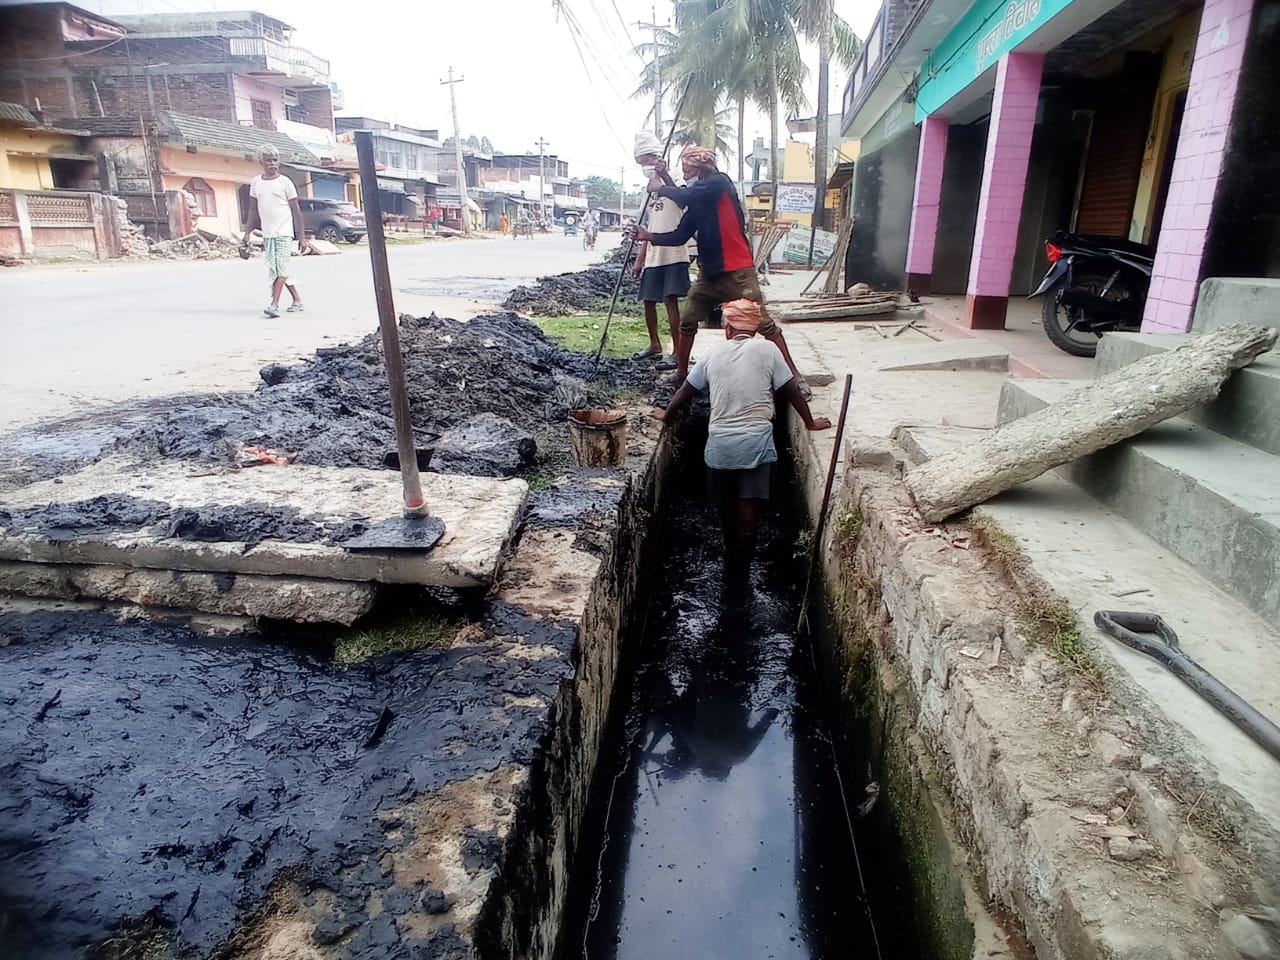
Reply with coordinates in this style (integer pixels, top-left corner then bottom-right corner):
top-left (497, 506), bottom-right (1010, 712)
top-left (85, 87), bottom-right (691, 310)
top-left (0, 234), bottom-right (618, 430)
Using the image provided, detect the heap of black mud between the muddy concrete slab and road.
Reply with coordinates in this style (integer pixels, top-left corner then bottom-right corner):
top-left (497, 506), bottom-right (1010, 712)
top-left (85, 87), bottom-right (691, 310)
top-left (0, 314), bottom-right (654, 483)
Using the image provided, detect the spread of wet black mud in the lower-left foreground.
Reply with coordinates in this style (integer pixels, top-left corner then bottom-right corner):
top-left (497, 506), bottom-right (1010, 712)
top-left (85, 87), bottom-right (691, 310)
top-left (0, 604), bottom-right (575, 960)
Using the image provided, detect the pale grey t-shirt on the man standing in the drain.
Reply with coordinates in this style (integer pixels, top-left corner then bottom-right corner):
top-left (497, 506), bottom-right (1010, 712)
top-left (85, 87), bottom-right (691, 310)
top-left (689, 337), bottom-right (791, 470)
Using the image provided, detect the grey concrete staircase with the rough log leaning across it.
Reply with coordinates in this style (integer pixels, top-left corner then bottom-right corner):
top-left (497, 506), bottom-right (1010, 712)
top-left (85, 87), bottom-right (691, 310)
top-left (998, 312), bottom-right (1280, 623)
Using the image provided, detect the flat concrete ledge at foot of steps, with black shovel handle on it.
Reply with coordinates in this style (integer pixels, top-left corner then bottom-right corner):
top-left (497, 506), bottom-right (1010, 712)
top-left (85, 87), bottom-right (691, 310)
top-left (895, 426), bottom-right (1280, 876)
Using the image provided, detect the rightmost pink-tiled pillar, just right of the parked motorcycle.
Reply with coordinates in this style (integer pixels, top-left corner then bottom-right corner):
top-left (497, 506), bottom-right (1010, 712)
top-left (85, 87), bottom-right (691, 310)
top-left (1142, 0), bottom-right (1253, 333)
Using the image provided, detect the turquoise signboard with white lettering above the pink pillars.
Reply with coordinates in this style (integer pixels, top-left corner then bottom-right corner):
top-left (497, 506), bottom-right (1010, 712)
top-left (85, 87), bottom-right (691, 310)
top-left (915, 0), bottom-right (1073, 123)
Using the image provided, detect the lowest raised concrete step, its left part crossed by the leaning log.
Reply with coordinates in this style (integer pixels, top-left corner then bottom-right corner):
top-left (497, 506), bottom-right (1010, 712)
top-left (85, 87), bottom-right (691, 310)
top-left (1000, 380), bottom-right (1280, 622)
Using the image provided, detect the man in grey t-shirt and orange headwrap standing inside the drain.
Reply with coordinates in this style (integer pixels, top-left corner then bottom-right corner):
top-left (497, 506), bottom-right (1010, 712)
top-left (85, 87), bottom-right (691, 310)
top-left (654, 300), bottom-right (831, 580)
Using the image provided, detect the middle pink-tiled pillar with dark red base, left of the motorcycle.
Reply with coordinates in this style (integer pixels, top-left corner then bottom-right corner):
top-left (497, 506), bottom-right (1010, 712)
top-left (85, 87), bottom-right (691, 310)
top-left (964, 54), bottom-right (1044, 330)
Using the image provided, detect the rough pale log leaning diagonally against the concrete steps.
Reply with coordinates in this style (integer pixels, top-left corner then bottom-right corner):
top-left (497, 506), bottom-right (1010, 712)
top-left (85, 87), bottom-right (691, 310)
top-left (906, 324), bottom-right (1276, 522)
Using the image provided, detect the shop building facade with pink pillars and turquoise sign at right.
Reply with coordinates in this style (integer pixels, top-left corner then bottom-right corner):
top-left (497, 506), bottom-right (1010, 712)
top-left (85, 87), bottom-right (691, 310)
top-left (844, 0), bottom-right (1280, 332)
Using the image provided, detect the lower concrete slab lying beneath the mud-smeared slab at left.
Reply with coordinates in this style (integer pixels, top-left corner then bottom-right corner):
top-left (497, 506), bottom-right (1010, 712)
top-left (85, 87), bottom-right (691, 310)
top-left (0, 561), bottom-right (378, 625)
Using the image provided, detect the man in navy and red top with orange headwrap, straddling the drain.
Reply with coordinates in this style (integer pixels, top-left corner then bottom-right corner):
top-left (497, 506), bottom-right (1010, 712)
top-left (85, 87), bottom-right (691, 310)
top-left (636, 146), bottom-right (809, 396)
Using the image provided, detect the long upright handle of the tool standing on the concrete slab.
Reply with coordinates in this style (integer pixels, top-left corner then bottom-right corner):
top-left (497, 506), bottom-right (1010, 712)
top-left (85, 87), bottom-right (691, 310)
top-left (356, 131), bottom-right (430, 515)
